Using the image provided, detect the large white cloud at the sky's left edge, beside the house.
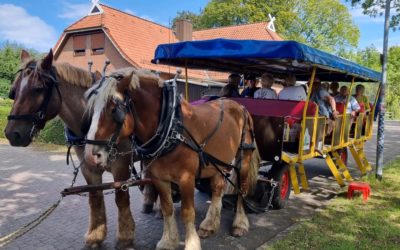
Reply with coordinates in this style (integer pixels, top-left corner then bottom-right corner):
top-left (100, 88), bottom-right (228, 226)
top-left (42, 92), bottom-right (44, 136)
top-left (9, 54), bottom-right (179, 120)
top-left (0, 4), bottom-right (57, 51)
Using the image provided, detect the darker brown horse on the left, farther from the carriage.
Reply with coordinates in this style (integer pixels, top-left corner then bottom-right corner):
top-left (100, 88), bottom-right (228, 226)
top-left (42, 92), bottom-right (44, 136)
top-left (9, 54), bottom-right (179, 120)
top-left (5, 51), bottom-right (135, 248)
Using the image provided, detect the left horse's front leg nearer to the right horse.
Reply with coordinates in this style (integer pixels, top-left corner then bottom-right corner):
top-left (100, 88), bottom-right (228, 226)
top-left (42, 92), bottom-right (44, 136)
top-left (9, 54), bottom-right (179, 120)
top-left (111, 162), bottom-right (135, 249)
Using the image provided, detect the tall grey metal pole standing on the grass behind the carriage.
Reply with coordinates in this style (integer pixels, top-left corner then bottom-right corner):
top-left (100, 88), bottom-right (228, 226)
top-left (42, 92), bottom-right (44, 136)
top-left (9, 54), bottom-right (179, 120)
top-left (376, 0), bottom-right (391, 180)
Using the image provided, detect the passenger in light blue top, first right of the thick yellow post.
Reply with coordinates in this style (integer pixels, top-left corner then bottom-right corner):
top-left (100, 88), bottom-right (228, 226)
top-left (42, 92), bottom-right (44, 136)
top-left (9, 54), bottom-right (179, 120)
top-left (310, 78), bottom-right (339, 135)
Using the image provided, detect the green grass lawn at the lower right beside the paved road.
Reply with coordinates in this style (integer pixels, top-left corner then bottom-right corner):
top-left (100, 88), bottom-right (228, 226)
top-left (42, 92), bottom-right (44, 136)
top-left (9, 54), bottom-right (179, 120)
top-left (268, 160), bottom-right (400, 249)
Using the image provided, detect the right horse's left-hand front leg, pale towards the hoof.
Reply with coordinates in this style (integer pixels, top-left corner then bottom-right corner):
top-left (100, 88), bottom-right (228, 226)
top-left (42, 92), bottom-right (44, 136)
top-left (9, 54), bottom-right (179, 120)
top-left (153, 178), bottom-right (179, 249)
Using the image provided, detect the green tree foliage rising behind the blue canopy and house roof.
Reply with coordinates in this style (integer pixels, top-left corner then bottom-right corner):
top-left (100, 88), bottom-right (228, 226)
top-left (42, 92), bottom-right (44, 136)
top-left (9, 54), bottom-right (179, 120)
top-left (175, 0), bottom-right (360, 52)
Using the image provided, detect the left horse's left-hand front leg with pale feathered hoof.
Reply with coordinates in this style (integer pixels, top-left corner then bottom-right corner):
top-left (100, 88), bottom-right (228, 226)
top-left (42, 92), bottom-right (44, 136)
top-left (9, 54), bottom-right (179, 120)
top-left (81, 163), bottom-right (107, 248)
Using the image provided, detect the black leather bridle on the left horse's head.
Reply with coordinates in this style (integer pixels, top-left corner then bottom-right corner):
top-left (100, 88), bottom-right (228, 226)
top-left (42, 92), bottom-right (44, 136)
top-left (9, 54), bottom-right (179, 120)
top-left (7, 62), bottom-right (62, 138)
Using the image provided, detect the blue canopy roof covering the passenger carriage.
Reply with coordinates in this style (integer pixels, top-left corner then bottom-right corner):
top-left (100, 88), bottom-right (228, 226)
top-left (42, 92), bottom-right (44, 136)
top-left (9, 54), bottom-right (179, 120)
top-left (152, 39), bottom-right (381, 82)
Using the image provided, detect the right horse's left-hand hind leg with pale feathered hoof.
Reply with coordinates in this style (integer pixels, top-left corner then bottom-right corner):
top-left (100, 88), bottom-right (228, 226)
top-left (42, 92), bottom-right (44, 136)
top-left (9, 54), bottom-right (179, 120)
top-left (199, 174), bottom-right (225, 238)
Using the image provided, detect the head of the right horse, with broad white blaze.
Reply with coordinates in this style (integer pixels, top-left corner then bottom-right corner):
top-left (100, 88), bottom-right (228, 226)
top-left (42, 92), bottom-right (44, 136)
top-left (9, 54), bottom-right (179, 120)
top-left (85, 69), bottom-right (138, 167)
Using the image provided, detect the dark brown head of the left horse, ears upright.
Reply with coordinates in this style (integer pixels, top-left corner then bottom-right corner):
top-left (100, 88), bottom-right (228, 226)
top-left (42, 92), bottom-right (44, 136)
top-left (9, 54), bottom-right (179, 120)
top-left (4, 50), bottom-right (62, 147)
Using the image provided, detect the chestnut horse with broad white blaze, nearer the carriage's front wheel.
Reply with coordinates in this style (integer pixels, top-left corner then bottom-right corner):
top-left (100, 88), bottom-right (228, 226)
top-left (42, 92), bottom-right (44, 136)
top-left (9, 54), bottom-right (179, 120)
top-left (85, 68), bottom-right (258, 250)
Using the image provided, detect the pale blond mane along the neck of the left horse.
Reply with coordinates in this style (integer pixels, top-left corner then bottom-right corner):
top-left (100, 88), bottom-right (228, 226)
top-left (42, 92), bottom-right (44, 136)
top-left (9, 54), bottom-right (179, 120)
top-left (54, 63), bottom-right (93, 88)
